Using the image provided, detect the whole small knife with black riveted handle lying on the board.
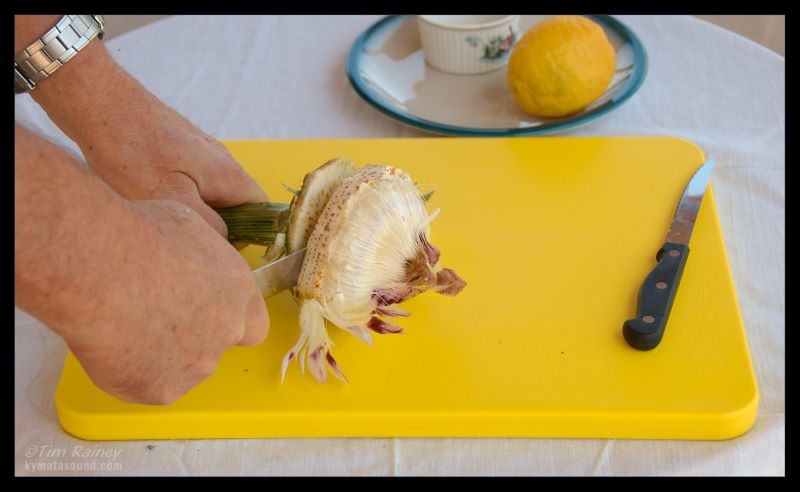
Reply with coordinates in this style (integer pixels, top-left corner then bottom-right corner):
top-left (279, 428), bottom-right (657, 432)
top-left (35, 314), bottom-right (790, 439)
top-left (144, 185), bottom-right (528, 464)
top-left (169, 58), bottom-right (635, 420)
top-left (622, 159), bottom-right (714, 350)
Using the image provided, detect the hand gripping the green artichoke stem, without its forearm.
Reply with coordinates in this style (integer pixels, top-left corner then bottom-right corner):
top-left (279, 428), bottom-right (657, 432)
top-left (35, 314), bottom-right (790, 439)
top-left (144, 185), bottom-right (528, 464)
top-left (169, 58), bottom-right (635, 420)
top-left (78, 89), bottom-right (269, 237)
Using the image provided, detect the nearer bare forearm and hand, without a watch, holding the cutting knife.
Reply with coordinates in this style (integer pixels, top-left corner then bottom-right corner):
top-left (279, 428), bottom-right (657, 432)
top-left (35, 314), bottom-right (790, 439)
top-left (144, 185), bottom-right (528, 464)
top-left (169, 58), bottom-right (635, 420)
top-left (14, 125), bottom-right (269, 404)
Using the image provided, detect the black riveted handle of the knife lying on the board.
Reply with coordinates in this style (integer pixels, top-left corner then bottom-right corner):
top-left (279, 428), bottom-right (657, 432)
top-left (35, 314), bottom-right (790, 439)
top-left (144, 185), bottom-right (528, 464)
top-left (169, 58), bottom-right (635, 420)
top-left (622, 242), bottom-right (689, 350)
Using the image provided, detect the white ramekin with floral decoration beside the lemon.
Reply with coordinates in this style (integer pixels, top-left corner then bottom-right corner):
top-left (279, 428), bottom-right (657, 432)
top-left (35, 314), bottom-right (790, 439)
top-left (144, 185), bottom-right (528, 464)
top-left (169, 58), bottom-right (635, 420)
top-left (417, 15), bottom-right (519, 74)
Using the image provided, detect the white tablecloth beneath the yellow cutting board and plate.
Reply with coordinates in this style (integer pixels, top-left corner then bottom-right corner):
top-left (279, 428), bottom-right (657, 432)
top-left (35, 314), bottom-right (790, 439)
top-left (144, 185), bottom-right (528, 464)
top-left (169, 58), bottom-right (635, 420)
top-left (14, 16), bottom-right (786, 475)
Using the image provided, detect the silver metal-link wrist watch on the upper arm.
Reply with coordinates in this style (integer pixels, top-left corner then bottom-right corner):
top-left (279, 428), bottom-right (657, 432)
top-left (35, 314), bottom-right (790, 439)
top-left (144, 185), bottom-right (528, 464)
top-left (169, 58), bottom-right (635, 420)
top-left (14, 15), bottom-right (105, 94)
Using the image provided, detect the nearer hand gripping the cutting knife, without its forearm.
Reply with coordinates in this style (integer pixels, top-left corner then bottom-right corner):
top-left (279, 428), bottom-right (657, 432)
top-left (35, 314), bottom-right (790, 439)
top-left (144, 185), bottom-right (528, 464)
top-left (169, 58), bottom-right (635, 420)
top-left (60, 200), bottom-right (269, 404)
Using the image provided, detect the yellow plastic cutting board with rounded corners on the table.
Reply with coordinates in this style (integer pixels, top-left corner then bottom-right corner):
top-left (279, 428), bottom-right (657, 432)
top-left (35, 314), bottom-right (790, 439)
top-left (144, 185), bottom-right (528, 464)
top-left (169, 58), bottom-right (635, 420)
top-left (55, 137), bottom-right (758, 439)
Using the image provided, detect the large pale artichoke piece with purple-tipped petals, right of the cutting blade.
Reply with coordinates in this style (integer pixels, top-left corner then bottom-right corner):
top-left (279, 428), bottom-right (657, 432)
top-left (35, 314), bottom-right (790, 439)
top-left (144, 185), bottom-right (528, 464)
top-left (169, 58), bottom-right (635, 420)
top-left (281, 165), bottom-right (466, 383)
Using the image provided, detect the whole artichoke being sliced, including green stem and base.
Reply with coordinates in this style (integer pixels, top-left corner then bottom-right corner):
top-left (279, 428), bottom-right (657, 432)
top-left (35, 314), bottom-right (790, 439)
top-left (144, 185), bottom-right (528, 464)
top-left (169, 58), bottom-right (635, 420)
top-left (217, 158), bottom-right (466, 383)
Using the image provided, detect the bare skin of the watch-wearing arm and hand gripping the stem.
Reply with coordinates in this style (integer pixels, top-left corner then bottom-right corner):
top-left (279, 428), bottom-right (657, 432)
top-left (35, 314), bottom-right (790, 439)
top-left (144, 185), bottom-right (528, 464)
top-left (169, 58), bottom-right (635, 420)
top-left (15, 27), bottom-right (268, 236)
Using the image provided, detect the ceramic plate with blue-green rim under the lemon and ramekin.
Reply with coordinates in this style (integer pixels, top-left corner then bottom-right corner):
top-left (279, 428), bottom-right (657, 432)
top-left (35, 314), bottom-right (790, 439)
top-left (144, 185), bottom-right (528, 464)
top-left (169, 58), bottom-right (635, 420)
top-left (347, 15), bottom-right (647, 136)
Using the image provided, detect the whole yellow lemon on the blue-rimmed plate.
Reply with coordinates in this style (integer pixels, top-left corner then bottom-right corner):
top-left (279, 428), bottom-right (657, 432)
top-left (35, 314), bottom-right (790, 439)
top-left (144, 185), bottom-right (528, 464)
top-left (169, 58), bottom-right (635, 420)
top-left (508, 15), bottom-right (616, 117)
